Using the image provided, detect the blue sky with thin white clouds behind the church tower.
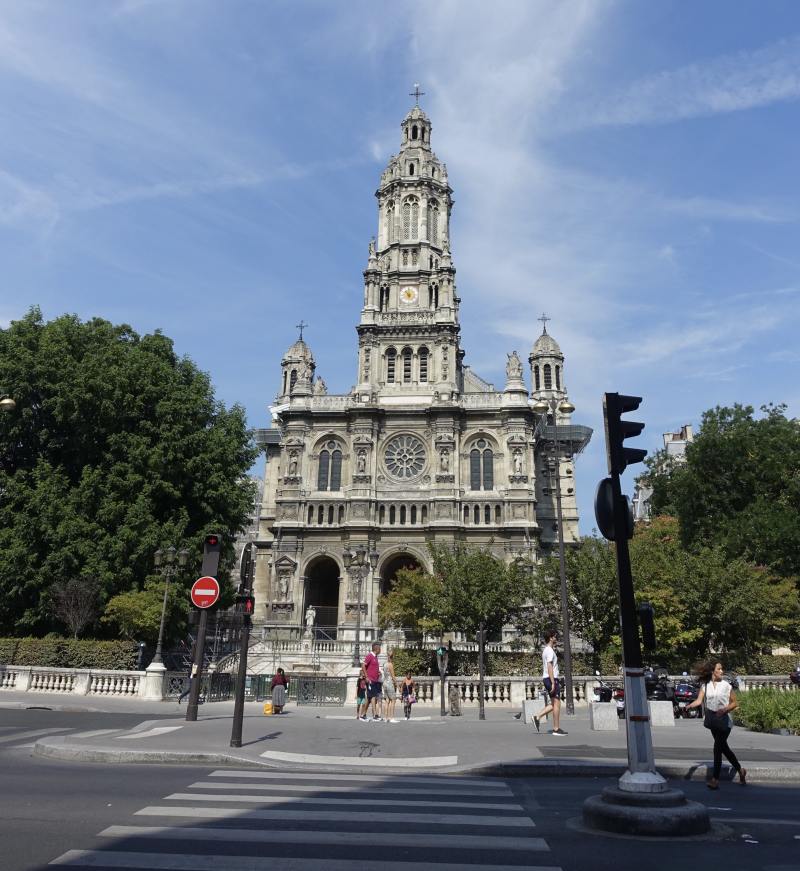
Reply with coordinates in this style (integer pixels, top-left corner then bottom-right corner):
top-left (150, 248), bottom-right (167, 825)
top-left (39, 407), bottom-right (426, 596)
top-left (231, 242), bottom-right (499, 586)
top-left (0, 0), bottom-right (800, 533)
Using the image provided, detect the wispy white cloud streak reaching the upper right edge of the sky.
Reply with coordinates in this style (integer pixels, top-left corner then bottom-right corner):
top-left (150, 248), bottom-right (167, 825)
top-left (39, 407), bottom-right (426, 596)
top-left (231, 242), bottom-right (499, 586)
top-left (559, 37), bottom-right (800, 130)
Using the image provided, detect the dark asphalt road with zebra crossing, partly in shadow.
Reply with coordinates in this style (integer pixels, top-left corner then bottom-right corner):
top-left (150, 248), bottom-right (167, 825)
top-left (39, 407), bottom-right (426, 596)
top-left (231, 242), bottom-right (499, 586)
top-left (0, 710), bottom-right (800, 871)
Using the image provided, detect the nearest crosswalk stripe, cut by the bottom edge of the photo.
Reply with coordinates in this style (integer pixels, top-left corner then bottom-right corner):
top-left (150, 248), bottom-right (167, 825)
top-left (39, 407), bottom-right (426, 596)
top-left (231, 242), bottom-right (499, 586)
top-left (50, 850), bottom-right (561, 871)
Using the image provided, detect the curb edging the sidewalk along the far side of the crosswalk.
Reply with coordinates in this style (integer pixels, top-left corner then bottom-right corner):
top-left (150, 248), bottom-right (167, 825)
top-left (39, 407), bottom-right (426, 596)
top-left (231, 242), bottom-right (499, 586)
top-left (33, 736), bottom-right (800, 783)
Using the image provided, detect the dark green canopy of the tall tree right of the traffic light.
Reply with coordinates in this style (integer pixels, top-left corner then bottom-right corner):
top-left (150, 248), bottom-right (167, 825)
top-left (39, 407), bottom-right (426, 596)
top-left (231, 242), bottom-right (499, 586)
top-left (643, 405), bottom-right (800, 578)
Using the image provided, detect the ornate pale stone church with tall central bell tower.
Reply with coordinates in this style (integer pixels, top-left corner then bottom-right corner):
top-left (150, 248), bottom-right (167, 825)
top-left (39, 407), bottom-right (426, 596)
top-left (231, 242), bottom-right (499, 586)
top-left (255, 105), bottom-right (589, 640)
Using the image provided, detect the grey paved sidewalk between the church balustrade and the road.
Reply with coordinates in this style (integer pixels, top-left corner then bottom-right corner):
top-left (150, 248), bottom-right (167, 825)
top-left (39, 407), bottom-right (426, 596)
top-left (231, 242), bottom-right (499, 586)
top-left (7, 694), bottom-right (800, 783)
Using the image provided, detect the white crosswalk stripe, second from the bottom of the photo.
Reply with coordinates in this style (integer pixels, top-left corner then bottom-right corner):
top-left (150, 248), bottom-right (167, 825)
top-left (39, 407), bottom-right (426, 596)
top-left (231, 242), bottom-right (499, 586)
top-left (98, 826), bottom-right (550, 852)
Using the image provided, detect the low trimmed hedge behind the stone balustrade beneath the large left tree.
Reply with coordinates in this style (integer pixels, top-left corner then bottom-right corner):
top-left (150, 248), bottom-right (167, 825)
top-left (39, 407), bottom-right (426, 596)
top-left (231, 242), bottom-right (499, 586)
top-left (0, 635), bottom-right (139, 670)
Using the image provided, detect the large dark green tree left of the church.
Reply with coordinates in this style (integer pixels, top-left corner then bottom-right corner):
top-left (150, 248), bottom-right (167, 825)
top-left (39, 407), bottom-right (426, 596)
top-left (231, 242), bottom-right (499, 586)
top-left (0, 309), bottom-right (256, 634)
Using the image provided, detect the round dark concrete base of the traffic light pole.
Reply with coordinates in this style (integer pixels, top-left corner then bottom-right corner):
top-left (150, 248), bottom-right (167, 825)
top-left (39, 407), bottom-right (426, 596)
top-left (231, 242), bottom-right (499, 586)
top-left (583, 786), bottom-right (711, 837)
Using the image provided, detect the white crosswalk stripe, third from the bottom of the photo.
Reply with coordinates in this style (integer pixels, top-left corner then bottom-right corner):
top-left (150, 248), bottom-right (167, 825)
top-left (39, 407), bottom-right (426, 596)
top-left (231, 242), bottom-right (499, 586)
top-left (135, 805), bottom-right (534, 829)
